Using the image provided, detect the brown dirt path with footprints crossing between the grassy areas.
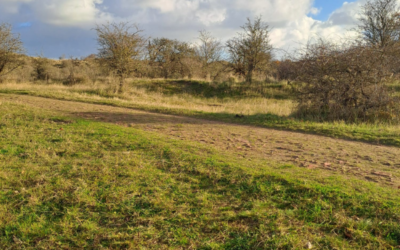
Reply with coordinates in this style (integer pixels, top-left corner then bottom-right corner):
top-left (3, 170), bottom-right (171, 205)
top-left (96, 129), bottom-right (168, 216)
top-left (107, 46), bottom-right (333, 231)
top-left (0, 95), bottom-right (400, 188)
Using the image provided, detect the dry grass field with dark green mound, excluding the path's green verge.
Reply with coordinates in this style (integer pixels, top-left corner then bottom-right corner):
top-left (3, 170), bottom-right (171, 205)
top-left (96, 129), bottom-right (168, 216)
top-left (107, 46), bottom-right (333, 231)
top-left (0, 80), bottom-right (293, 116)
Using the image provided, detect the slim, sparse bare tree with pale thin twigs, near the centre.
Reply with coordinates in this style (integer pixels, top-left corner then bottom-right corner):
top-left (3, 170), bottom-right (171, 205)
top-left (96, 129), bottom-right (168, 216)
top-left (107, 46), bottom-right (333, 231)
top-left (196, 30), bottom-right (224, 78)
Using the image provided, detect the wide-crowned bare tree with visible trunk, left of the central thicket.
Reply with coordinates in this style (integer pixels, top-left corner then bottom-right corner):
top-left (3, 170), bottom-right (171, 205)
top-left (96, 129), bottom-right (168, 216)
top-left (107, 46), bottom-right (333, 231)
top-left (95, 22), bottom-right (146, 92)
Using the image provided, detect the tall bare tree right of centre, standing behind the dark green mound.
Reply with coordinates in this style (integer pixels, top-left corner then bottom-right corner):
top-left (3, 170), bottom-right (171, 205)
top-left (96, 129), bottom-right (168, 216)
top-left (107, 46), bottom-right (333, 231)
top-left (226, 17), bottom-right (272, 83)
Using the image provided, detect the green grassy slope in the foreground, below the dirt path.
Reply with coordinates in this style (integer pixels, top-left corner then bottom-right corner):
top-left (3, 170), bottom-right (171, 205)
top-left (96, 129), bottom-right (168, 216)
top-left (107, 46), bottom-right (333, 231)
top-left (0, 103), bottom-right (400, 249)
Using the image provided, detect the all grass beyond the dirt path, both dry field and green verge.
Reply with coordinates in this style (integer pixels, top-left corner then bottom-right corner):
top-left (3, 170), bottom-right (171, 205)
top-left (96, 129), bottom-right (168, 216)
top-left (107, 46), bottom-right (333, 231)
top-left (0, 80), bottom-right (400, 146)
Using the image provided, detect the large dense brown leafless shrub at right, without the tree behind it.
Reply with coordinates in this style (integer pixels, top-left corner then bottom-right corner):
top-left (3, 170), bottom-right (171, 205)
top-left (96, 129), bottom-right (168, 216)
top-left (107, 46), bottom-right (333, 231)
top-left (291, 40), bottom-right (399, 124)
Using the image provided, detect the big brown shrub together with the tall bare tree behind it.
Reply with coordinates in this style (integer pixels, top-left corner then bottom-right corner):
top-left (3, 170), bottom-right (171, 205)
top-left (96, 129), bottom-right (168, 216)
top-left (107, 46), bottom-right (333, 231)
top-left (277, 0), bottom-right (400, 123)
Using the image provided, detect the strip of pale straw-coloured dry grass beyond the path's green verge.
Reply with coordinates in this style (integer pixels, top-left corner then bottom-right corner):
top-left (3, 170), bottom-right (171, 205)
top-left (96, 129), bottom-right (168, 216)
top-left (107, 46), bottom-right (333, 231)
top-left (0, 81), bottom-right (294, 116)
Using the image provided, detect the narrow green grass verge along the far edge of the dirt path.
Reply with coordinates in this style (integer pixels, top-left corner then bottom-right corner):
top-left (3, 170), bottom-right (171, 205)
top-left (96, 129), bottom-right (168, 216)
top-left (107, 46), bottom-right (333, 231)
top-left (0, 83), bottom-right (400, 147)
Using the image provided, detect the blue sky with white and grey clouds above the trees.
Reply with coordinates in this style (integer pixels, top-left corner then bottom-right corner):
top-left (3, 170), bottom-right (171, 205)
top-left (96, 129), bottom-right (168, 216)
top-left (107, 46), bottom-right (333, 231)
top-left (0, 0), bottom-right (366, 58)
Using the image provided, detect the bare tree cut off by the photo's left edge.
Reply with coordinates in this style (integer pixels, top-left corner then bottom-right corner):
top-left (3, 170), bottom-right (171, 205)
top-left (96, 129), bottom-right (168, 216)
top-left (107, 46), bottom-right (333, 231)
top-left (0, 23), bottom-right (24, 76)
